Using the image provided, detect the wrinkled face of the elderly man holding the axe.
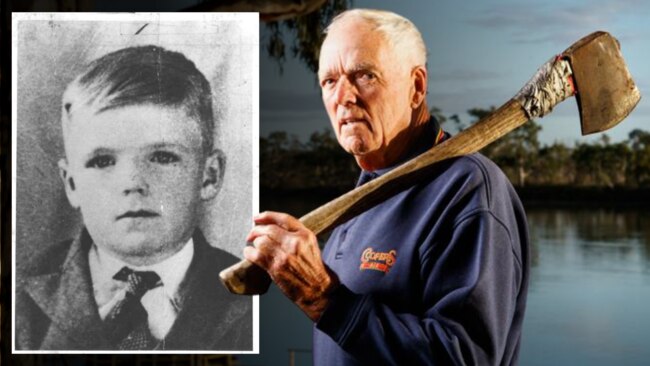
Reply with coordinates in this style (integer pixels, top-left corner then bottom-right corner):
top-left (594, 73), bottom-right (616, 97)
top-left (318, 19), bottom-right (413, 168)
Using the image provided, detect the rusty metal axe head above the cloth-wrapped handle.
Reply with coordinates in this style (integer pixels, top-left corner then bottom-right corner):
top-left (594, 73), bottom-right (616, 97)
top-left (562, 32), bottom-right (641, 135)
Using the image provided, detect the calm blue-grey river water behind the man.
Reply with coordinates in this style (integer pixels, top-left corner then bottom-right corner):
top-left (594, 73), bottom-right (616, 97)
top-left (240, 208), bottom-right (650, 366)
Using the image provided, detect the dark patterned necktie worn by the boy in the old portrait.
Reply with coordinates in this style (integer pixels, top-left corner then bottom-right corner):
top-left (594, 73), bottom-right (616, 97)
top-left (104, 267), bottom-right (162, 350)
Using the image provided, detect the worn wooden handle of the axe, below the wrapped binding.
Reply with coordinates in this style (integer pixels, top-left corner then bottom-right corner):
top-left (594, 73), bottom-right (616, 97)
top-left (219, 99), bottom-right (529, 295)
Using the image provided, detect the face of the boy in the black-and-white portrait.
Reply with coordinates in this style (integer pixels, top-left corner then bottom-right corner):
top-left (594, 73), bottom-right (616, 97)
top-left (59, 105), bottom-right (221, 265)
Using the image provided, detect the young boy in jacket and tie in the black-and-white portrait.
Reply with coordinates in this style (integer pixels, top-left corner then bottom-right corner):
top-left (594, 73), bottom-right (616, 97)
top-left (15, 46), bottom-right (252, 351)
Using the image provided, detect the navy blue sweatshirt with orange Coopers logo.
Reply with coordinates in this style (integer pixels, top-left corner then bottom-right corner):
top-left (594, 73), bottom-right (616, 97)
top-left (314, 122), bottom-right (529, 366)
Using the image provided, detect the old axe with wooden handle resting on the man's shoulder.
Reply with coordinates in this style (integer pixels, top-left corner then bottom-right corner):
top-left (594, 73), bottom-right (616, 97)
top-left (219, 32), bottom-right (641, 295)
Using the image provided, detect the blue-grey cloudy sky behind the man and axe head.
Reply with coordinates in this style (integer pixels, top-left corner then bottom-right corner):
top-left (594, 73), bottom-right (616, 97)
top-left (260, 0), bottom-right (650, 144)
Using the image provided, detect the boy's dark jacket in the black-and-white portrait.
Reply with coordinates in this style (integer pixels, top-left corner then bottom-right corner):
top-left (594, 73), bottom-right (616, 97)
top-left (15, 229), bottom-right (253, 351)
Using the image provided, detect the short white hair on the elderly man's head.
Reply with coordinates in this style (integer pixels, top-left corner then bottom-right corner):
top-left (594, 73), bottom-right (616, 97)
top-left (325, 9), bottom-right (427, 66)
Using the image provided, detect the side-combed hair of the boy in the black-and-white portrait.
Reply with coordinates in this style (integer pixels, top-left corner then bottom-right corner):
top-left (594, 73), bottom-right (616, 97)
top-left (62, 46), bottom-right (214, 152)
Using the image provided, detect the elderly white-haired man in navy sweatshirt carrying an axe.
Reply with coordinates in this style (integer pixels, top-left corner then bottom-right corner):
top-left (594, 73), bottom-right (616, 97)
top-left (244, 9), bottom-right (529, 365)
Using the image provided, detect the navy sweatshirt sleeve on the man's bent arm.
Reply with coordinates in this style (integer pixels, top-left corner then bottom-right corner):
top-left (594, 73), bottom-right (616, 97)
top-left (316, 210), bottom-right (522, 365)
